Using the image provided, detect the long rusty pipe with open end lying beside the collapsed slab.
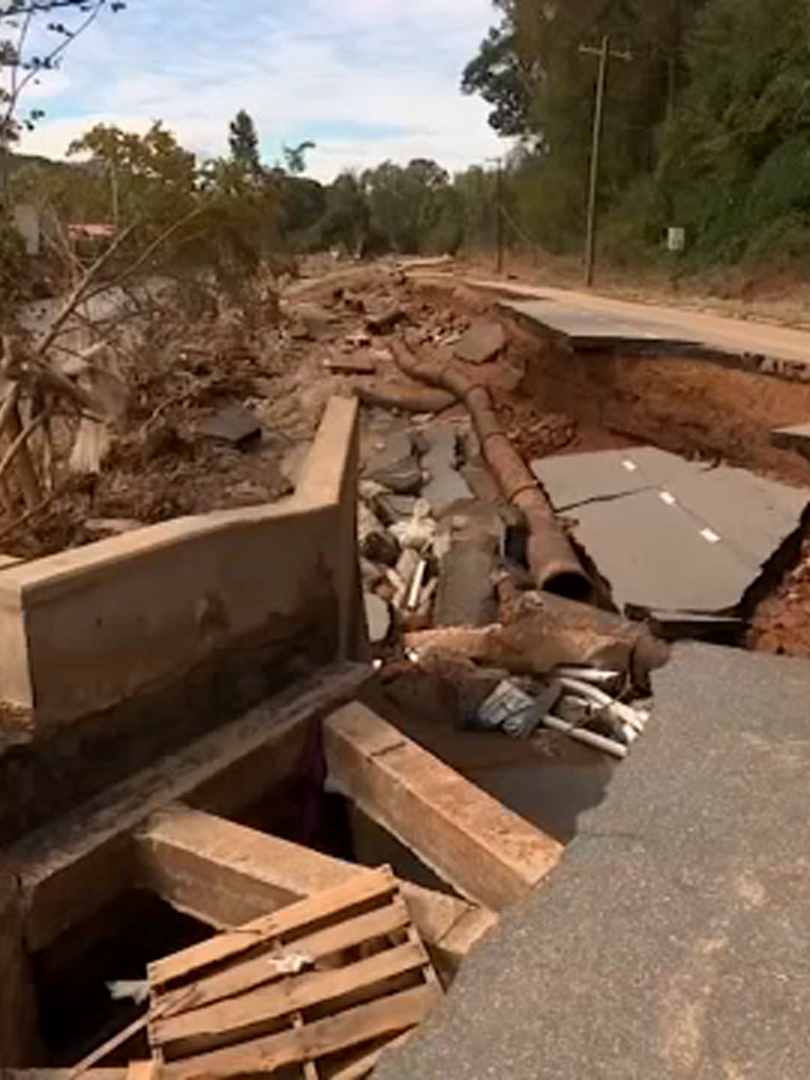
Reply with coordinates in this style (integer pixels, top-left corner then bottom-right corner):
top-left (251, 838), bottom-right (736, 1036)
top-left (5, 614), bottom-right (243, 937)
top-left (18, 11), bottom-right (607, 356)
top-left (391, 341), bottom-right (596, 600)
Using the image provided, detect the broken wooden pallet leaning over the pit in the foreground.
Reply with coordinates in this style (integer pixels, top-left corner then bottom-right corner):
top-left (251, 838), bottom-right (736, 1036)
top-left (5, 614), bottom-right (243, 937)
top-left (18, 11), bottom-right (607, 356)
top-left (142, 867), bottom-right (441, 1080)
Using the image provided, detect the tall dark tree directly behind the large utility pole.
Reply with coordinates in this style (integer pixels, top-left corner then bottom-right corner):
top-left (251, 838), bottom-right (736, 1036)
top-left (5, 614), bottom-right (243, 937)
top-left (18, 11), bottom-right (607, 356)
top-left (462, 0), bottom-right (706, 244)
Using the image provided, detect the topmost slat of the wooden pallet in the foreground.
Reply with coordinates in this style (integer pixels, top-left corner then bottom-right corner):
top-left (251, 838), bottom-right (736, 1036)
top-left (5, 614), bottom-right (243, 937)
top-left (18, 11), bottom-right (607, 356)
top-left (149, 867), bottom-right (397, 987)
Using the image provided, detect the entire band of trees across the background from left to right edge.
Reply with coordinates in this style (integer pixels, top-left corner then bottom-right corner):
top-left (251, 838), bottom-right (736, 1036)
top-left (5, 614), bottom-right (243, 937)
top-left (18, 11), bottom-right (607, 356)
top-left (6, 0), bottom-right (810, 281)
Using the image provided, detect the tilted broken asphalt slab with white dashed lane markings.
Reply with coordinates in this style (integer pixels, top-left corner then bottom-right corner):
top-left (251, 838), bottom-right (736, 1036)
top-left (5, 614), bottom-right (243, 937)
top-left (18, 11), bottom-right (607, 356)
top-left (532, 447), bottom-right (810, 631)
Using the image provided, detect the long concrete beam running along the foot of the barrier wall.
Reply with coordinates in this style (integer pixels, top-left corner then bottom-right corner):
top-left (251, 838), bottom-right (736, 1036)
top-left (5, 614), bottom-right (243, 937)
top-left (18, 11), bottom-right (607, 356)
top-left (12, 664), bottom-right (370, 951)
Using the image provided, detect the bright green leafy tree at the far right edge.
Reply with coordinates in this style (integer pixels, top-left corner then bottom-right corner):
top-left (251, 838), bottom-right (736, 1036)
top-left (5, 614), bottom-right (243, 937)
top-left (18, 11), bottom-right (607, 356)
top-left (657, 0), bottom-right (810, 261)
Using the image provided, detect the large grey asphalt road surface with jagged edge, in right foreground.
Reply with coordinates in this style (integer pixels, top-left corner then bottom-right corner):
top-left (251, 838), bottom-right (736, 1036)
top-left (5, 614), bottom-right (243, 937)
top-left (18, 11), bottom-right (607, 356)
top-left (376, 645), bottom-right (810, 1080)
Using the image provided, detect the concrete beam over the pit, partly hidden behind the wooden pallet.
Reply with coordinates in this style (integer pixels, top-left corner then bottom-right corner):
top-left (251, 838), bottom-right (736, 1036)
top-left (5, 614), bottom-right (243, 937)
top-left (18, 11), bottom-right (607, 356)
top-left (135, 804), bottom-right (497, 974)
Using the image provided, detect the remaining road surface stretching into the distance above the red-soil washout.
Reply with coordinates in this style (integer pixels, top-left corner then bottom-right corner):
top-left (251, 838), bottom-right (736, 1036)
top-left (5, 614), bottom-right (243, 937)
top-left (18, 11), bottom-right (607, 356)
top-left (419, 278), bottom-right (810, 378)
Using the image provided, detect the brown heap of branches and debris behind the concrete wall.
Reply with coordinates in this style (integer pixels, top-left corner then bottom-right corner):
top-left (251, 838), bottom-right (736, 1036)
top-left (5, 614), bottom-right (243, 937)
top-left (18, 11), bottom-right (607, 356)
top-left (0, 264), bottom-right (501, 558)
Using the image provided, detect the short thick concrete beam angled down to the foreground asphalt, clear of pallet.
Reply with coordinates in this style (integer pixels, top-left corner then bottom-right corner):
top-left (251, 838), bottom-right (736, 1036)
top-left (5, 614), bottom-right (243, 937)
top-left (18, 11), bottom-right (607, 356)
top-left (324, 702), bottom-right (564, 912)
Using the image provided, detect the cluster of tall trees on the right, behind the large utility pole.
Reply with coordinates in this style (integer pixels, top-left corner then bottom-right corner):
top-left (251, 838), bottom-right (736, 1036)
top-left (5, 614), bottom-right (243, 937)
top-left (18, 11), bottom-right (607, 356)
top-left (462, 0), bottom-right (810, 265)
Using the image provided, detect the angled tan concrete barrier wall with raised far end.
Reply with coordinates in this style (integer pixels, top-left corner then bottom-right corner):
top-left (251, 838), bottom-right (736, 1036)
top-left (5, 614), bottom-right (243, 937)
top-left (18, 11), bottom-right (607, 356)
top-left (0, 399), bottom-right (361, 732)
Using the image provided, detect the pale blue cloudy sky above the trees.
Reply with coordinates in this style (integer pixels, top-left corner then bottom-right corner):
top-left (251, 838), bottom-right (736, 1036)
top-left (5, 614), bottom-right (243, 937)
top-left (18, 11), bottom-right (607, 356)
top-left (11, 0), bottom-right (504, 180)
